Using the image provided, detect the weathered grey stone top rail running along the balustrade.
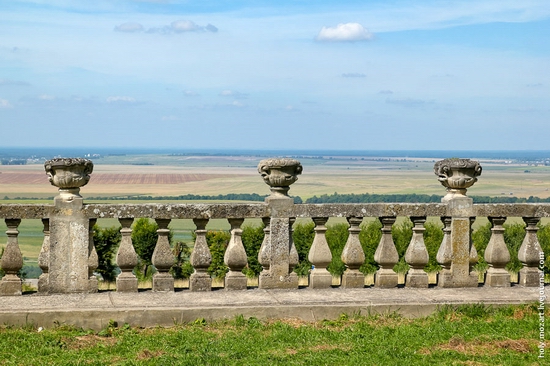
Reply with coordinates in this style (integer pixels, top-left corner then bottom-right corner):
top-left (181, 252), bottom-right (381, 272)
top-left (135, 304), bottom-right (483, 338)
top-left (0, 203), bottom-right (550, 219)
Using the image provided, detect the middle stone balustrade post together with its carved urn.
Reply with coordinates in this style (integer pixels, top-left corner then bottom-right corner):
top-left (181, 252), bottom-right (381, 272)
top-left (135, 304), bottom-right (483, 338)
top-left (258, 158), bottom-right (302, 289)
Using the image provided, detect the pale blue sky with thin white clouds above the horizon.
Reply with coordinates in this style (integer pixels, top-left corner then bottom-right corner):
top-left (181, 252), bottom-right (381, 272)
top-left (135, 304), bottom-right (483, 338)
top-left (0, 0), bottom-right (550, 150)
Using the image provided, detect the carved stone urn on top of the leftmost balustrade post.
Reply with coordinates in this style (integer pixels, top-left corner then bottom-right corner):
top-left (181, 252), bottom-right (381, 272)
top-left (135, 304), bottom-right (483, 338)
top-left (44, 158), bottom-right (94, 201)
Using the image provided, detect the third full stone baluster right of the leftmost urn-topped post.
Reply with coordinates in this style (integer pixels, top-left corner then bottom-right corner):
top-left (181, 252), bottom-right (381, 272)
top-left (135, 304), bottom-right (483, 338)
top-left (189, 219), bottom-right (212, 291)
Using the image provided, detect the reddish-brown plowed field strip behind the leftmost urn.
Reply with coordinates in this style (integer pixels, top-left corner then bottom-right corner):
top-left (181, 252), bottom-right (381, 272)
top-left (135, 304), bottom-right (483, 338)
top-left (0, 173), bottom-right (238, 185)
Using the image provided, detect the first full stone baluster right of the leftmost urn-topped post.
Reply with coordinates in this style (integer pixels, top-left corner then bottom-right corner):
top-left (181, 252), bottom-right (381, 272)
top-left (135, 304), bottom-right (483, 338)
top-left (116, 218), bottom-right (138, 292)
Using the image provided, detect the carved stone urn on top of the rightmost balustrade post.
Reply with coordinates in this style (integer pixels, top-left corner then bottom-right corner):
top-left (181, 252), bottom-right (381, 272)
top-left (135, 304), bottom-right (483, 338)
top-left (434, 158), bottom-right (481, 201)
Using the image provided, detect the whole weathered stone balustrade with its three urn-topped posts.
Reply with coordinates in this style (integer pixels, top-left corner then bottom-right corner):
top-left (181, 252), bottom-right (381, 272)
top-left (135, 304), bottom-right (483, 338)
top-left (0, 158), bottom-right (550, 295)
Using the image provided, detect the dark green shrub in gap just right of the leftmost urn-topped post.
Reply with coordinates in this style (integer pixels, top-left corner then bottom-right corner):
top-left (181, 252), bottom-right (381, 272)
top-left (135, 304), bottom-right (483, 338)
top-left (92, 224), bottom-right (122, 282)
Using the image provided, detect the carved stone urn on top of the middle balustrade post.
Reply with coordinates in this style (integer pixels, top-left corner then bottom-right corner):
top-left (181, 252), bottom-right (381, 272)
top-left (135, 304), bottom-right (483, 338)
top-left (258, 158), bottom-right (303, 196)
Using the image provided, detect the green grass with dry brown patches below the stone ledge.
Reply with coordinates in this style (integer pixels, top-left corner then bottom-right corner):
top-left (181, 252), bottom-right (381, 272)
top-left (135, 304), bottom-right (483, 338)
top-left (0, 305), bottom-right (548, 365)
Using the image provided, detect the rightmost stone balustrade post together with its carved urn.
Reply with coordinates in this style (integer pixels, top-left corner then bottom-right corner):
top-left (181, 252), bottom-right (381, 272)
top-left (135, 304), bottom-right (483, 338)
top-left (434, 158), bottom-right (482, 287)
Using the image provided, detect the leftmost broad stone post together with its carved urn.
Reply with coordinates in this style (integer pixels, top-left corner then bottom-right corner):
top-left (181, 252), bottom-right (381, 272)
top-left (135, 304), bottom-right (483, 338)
top-left (44, 158), bottom-right (93, 293)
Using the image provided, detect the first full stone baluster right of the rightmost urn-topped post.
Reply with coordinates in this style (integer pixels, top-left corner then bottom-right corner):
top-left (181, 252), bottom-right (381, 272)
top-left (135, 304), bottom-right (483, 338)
top-left (485, 217), bottom-right (510, 287)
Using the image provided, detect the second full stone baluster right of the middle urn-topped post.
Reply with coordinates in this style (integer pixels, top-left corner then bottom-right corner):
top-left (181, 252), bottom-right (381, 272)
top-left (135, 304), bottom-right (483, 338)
top-left (341, 217), bottom-right (365, 288)
